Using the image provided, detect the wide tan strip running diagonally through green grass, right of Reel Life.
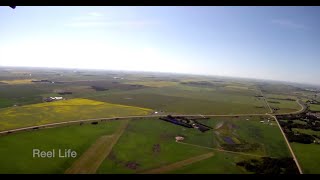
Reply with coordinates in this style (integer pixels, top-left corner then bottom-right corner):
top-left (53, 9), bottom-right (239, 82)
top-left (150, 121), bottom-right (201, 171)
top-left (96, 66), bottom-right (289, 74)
top-left (65, 120), bottom-right (129, 174)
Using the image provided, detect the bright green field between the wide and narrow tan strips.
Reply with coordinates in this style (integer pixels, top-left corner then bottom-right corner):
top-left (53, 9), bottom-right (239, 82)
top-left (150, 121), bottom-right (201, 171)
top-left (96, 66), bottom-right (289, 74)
top-left (98, 119), bottom-right (210, 174)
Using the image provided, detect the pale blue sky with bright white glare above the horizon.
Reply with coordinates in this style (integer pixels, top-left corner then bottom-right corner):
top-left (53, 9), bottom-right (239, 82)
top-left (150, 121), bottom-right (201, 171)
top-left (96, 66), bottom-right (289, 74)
top-left (0, 6), bottom-right (320, 85)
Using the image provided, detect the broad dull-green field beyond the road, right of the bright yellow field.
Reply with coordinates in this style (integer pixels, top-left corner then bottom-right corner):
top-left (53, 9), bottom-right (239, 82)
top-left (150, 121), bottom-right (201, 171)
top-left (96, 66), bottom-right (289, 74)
top-left (88, 83), bottom-right (267, 114)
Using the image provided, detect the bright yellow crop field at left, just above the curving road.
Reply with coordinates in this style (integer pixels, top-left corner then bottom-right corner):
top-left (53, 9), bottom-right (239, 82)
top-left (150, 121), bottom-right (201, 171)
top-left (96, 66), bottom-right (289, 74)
top-left (0, 99), bottom-right (151, 130)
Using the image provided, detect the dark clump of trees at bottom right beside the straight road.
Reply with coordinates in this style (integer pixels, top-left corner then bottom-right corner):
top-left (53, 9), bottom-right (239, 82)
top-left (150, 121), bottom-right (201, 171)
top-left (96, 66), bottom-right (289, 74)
top-left (237, 157), bottom-right (299, 174)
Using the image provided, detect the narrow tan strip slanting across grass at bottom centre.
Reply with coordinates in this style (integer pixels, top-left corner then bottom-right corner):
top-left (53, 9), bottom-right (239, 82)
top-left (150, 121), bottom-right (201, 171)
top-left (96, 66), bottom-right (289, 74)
top-left (140, 152), bottom-right (214, 174)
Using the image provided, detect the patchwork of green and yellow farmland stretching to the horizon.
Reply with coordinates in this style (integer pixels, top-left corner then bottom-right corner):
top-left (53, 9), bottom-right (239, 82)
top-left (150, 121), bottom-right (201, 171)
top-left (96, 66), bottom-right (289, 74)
top-left (0, 69), bottom-right (318, 174)
